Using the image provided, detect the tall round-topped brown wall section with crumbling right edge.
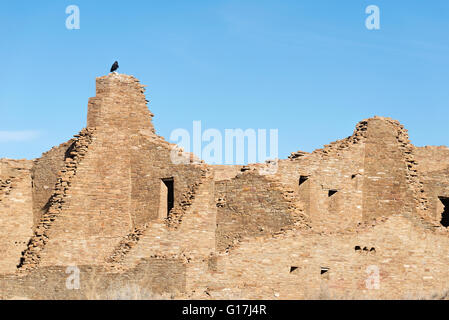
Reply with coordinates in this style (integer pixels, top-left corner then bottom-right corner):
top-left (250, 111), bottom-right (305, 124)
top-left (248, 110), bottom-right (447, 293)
top-left (363, 117), bottom-right (436, 228)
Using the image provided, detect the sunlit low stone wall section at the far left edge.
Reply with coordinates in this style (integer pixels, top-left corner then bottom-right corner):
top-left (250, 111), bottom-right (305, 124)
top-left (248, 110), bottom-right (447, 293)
top-left (0, 159), bottom-right (33, 273)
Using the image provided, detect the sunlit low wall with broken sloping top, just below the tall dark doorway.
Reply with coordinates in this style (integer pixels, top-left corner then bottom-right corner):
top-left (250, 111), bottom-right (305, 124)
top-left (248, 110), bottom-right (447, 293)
top-left (109, 175), bottom-right (217, 268)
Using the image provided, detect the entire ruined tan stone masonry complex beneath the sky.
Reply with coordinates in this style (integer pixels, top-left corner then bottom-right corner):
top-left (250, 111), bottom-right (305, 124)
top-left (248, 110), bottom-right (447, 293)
top-left (0, 74), bottom-right (449, 299)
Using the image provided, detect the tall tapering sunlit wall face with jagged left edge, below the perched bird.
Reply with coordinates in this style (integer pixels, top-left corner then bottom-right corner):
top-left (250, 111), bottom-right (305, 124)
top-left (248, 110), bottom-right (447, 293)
top-left (18, 77), bottom-right (145, 268)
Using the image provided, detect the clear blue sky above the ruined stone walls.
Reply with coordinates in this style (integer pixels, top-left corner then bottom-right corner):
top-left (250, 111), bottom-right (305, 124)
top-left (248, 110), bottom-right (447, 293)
top-left (0, 0), bottom-right (449, 158)
